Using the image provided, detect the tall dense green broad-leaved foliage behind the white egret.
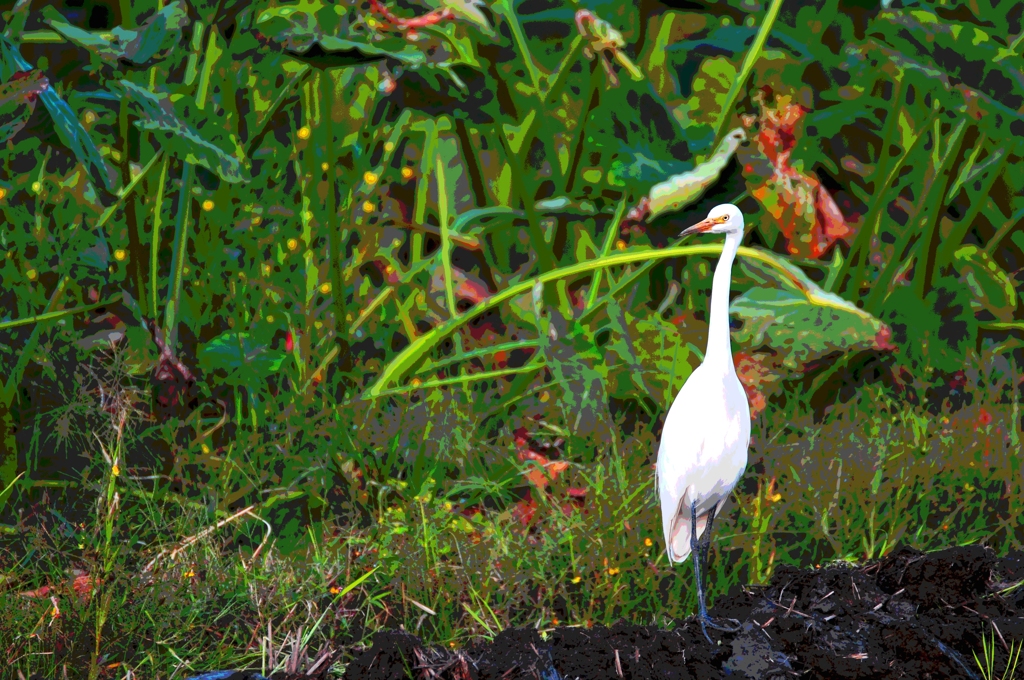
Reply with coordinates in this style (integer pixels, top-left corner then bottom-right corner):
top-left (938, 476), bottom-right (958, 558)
top-left (0, 0), bottom-right (1024, 667)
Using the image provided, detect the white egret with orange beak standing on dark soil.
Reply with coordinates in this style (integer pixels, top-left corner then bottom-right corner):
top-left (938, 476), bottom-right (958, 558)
top-left (656, 204), bottom-right (751, 642)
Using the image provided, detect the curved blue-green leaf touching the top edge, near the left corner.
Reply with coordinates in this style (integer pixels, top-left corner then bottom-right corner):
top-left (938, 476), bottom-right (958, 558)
top-left (42, 0), bottom-right (188, 66)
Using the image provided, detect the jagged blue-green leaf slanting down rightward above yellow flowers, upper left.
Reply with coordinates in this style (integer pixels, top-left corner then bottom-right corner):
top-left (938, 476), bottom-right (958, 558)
top-left (121, 80), bottom-right (245, 182)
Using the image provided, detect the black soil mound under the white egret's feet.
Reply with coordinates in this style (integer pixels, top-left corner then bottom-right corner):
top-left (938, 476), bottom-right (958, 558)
top-left (345, 546), bottom-right (1024, 680)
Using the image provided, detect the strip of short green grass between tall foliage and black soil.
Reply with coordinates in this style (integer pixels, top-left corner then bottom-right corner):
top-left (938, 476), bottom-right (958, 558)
top-left (0, 352), bottom-right (1024, 678)
